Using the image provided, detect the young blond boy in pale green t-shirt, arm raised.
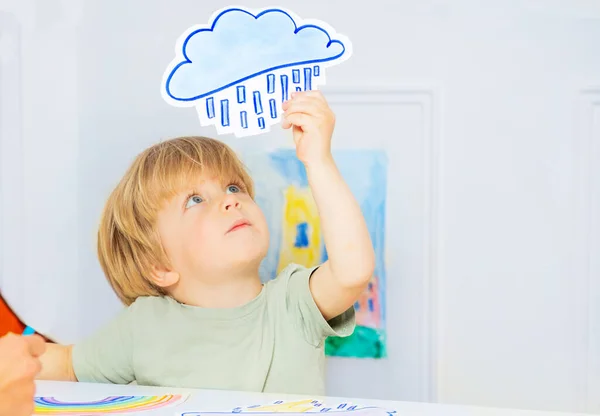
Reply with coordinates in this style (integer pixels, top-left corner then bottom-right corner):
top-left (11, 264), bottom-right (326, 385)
top-left (40, 91), bottom-right (375, 395)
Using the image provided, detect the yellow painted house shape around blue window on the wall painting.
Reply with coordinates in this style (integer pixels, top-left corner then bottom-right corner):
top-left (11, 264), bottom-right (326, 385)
top-left (277, 185), bottom-right (321, 273)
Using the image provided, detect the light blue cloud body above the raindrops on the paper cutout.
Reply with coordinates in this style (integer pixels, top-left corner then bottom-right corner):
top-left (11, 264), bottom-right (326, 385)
top-left (165, 8), bottom-right (346, 101)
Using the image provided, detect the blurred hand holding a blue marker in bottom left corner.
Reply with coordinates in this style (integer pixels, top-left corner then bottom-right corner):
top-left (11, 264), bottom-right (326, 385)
top-left (0, 334), bottom-right (46, 416)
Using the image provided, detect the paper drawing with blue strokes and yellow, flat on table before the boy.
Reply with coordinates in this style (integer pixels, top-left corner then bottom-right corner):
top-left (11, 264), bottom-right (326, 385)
top-left (181, 399), bottom-right (396, 416)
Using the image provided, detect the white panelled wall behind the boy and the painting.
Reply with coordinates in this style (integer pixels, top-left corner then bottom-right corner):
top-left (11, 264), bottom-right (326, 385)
top-left (0, 0), bottom-right (600, 413)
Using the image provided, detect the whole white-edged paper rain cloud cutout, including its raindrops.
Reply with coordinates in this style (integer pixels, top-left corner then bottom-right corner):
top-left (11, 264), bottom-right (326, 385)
top-left (161, 7), bottom-right (352, 137)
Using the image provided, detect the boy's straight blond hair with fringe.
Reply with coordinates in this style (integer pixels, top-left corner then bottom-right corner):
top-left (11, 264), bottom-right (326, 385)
top-left (98, 137), bottom-right (254, 305)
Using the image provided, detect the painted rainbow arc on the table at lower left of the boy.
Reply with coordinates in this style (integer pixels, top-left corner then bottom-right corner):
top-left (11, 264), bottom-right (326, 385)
top-left (34, 394), bottom-right (187, 415)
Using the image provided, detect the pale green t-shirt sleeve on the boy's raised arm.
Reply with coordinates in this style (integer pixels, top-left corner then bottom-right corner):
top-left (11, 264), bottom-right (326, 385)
top-left (278, 264), bottom-right (356, 346)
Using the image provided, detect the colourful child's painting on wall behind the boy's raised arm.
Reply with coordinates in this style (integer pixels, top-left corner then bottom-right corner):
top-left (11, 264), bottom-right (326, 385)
top-left (241, 149), bottom-right (387, 358)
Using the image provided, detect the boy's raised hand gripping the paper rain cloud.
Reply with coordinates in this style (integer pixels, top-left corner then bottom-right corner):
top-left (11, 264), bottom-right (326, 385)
top-left (282, 91), bottom-right (335, 166)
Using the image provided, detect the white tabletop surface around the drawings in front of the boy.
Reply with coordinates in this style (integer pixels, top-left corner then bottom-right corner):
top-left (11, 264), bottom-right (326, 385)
top-left (36, 381), bottom-right (592, 416)
